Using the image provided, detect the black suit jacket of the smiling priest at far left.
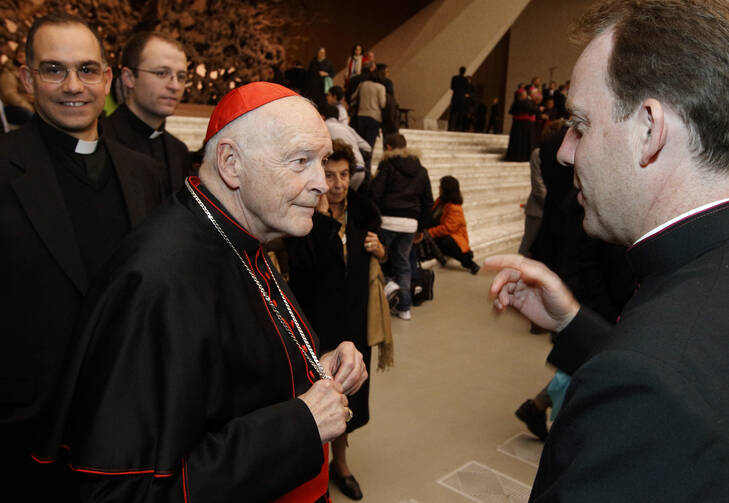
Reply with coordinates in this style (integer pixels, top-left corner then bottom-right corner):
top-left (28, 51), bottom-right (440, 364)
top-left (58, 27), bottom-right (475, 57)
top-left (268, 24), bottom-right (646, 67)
top-left (0, 121), bottom-right (162, 501)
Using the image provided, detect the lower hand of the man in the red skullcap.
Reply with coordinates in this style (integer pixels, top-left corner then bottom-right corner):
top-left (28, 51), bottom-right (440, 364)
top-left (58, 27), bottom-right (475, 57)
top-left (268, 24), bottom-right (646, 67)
top-left (299, 379), bottom-right (348, 444)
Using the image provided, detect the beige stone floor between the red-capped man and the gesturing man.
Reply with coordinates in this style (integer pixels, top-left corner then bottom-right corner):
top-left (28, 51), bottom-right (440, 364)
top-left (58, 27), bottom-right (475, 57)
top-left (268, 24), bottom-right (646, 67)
top-left (331, 261), bottom-right (552, 503)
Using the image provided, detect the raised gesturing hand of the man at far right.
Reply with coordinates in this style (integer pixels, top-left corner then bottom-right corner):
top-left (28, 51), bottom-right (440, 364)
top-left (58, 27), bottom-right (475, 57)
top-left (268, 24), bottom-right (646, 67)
top-left (484, 255), bottom-right (580, 332)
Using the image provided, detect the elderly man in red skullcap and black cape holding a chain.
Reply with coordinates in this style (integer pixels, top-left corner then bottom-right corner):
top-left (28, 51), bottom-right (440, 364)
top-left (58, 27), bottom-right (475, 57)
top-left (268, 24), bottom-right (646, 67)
top-left (41, 82), bottom-right (367, 503)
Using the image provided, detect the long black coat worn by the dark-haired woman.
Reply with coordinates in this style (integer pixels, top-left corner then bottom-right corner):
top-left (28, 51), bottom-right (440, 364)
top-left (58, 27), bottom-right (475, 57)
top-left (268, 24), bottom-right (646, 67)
top-left (286, 191), bottom-right (380, 431)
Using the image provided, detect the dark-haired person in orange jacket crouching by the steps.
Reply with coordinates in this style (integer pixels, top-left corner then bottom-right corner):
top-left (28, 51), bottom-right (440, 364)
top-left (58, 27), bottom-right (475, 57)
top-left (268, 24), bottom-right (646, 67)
top-left (428, 175), bottom-right (480, 274)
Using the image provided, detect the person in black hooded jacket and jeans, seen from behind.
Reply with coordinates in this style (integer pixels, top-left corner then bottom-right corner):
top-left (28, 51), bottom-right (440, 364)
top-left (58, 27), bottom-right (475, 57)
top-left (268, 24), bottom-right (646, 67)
top-left (370, 134), bottom-right (433, 320)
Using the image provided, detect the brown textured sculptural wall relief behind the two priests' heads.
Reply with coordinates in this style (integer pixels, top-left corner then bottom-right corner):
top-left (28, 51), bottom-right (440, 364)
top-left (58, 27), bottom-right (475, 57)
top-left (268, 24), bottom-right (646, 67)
top-left (0, 0), bottom-right (305, 104)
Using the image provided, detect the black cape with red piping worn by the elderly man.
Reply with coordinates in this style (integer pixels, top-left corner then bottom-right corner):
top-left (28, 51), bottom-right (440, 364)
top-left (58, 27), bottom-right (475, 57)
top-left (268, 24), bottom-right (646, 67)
top-left (44, 179), bottom-right (326, 503)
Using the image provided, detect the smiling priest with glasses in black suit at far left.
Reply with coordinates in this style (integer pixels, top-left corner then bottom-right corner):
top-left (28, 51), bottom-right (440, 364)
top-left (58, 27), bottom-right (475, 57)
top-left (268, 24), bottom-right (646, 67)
top-left (0, 14), bottom-right (162, 502)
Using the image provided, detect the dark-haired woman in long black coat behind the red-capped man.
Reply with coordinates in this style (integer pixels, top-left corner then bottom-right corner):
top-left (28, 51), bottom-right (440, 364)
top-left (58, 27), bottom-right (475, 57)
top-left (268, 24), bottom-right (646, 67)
top-left (286, 140), bottom-right (385, 500)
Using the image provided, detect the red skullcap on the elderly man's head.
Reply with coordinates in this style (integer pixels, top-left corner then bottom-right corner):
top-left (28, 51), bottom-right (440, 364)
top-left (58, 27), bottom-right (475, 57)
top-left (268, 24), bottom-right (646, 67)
top-left (203, 82), bottom-right (299, 143)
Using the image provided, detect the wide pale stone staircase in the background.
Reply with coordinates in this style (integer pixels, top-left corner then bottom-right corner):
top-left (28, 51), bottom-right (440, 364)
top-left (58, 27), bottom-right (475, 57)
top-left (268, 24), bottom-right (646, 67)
top-left (167, 116), bottom-right (530, 260)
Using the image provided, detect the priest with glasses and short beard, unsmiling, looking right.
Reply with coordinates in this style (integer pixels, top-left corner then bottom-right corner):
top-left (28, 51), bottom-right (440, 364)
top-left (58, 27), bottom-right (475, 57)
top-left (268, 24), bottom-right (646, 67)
top-left (103, 32), bottom-right (192, 194)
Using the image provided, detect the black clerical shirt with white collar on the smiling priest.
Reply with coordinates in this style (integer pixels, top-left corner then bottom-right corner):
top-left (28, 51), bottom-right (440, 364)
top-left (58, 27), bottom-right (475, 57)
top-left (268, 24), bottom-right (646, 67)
top-left (38, 115), bottom-right (131, 277)
